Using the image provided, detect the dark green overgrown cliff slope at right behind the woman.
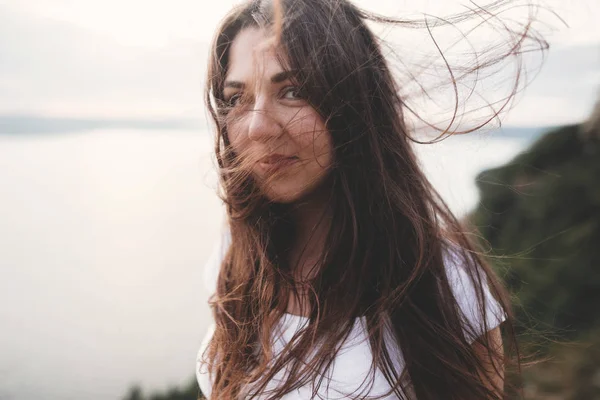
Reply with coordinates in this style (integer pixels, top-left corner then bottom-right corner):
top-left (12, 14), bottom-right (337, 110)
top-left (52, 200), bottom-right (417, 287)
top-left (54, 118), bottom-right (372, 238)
top-left (470, 124), bottom-right (600, 400)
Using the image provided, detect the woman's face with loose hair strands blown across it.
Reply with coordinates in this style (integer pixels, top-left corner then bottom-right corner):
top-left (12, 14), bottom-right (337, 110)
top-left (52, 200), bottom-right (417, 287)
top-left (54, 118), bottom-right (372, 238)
top-left (223, 28), bottom-right (333, 203)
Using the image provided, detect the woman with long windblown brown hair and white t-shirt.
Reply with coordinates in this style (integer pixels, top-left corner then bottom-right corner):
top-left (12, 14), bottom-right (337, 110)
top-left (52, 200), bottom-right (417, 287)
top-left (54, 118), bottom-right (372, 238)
top-left (197, 0), bottom-right (540, 400)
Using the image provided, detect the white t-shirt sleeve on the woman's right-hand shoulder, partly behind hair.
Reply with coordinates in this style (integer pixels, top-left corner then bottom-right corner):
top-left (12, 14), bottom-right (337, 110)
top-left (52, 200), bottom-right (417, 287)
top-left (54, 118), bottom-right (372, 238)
top-left (445, 247), bottom-right (506, 343)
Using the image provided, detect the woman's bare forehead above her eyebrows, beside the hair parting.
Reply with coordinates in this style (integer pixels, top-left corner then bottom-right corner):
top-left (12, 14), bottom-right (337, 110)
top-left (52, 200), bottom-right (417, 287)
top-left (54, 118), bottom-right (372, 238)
top-left (225, 28), bottom-right (283, 82)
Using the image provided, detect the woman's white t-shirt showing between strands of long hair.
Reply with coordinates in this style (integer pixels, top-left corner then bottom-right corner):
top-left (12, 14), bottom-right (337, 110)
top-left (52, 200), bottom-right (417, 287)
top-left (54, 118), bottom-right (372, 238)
top-left (196, 236), bottom-right (505, 400)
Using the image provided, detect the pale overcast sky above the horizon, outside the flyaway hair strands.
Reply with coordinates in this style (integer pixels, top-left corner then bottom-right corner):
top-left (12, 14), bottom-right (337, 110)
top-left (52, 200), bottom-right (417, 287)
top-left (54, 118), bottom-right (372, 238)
top-left (0, 0), bottom-right (600, 125)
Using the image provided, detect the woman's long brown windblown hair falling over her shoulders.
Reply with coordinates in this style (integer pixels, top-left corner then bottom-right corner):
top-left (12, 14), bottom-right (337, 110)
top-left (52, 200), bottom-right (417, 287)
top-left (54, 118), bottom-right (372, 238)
top-left (206, 0), bottom-right (548, 400)
